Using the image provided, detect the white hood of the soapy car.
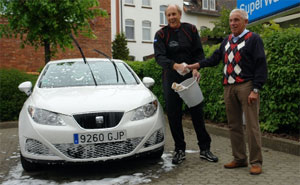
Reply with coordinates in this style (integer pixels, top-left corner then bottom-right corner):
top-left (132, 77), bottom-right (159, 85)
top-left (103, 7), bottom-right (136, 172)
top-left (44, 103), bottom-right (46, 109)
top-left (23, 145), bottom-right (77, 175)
top-left (31, 84), bottom-right (154, 115)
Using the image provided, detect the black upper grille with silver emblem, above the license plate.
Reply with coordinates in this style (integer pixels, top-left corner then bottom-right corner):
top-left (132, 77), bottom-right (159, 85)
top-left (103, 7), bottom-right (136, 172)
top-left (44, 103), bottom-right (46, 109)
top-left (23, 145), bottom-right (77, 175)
top-left (73, 112), bottom-right (124, 129)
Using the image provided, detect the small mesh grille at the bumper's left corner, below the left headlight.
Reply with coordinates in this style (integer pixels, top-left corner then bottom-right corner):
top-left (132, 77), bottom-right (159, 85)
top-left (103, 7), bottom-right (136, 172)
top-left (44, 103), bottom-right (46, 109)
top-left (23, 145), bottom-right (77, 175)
top-left (25, 139), bottom-right (55, 156)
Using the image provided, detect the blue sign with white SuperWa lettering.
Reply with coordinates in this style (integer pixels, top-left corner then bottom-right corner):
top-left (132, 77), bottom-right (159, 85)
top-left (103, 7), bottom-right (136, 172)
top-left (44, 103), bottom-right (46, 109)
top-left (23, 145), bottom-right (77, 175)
top-left (237, 0), bottom-right (300, 23)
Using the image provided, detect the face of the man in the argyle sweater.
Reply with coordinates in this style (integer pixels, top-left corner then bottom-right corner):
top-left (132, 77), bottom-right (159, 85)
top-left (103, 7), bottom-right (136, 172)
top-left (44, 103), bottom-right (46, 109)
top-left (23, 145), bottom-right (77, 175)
top-left (229, 12), bottom-right (248, 36)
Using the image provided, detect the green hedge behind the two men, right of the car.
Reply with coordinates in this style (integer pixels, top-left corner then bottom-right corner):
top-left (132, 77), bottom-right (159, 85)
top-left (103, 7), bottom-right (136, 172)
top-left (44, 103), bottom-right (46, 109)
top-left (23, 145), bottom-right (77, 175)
top-left (129, 27), bottom-right (300, 133)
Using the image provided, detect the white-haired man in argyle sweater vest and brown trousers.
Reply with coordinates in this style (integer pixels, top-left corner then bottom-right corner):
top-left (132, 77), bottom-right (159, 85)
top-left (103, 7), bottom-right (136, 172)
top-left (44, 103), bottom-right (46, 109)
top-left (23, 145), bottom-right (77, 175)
top-left (186, 9), bottom-right (267, 175)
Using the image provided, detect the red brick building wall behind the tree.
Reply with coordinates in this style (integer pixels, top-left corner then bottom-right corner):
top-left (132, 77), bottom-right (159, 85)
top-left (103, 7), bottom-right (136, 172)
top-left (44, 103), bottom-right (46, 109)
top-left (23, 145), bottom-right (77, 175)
top-left (0, 0), bottom-right (111, 72)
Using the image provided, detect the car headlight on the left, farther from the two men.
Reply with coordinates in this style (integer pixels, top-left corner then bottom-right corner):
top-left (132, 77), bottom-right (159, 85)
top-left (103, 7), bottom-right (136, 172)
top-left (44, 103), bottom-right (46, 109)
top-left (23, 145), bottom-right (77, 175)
top-left (28, 106), bottom-right (66, 126)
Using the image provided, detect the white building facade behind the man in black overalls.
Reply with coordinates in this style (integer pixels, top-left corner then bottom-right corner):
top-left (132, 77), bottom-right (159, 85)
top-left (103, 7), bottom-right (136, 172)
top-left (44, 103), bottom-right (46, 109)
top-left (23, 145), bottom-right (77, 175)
top-left (111, 0), bottom-right (216, 61)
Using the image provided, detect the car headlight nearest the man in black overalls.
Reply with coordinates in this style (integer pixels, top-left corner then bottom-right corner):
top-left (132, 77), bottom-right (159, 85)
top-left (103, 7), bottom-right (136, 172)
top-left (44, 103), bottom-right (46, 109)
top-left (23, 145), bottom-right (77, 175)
top-left (131, 100), bottom-right (158, 121)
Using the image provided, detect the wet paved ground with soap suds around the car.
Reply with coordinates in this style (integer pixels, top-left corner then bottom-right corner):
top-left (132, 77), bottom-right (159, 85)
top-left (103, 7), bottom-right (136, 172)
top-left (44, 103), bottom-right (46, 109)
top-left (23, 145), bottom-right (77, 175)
top-left (0, 121), bottom-right (300, 185)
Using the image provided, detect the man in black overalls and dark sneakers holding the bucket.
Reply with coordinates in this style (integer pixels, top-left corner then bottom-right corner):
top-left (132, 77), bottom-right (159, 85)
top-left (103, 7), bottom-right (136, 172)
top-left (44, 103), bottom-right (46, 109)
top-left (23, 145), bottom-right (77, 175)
top-left (154, 5), bottom-right (218, 164)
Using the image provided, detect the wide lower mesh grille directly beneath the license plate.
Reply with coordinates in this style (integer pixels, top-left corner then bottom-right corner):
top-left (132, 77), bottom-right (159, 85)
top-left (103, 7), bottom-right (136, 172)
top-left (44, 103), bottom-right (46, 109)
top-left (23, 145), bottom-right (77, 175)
top-left (54, 137), bottom-right (143, 159)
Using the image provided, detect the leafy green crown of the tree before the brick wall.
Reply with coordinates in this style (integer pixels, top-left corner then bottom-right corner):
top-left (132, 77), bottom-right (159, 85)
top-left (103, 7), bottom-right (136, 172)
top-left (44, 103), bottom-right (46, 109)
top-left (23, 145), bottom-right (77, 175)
top-left (0, 0), bottom-right (107, 63)
